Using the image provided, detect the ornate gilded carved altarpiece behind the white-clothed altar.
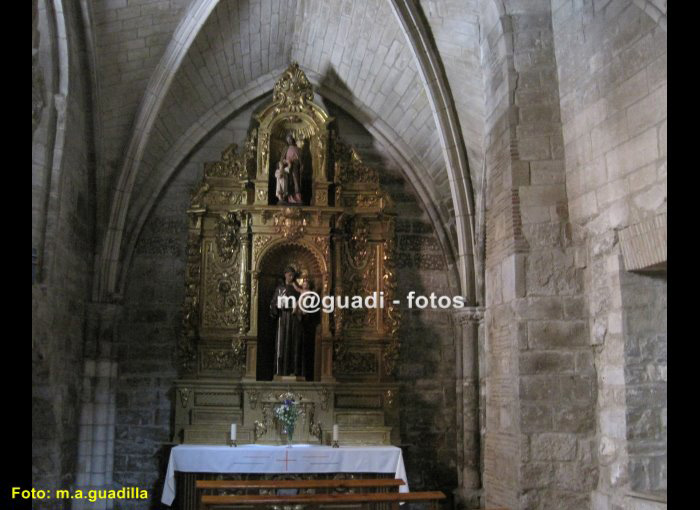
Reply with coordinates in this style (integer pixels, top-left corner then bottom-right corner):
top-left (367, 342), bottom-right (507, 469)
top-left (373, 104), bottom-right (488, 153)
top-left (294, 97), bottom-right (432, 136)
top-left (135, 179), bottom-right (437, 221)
top-left (174, 64), bottom-right (399, 444)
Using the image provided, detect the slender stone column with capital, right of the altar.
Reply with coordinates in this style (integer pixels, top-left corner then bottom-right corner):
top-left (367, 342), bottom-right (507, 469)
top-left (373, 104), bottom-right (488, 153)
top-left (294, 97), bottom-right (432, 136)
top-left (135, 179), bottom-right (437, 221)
top-left (454, 306), bottom-right (484, 508)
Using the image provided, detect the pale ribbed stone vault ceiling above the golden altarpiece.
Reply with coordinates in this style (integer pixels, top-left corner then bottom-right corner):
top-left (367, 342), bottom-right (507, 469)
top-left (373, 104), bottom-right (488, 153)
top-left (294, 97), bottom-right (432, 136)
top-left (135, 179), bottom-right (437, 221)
top-left (87, 0), bottom-right (484, 298)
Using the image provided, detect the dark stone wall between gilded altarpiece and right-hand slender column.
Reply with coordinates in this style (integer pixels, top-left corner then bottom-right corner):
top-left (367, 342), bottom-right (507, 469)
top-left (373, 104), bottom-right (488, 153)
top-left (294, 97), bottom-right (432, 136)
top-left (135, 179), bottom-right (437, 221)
top-left (327, 104), bottom-right (457, 500)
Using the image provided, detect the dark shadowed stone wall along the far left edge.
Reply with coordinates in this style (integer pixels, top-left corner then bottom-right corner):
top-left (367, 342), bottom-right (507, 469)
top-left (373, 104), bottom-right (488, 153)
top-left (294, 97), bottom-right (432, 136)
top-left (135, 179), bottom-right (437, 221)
top-left (32, 2), bottom-right (95, 508)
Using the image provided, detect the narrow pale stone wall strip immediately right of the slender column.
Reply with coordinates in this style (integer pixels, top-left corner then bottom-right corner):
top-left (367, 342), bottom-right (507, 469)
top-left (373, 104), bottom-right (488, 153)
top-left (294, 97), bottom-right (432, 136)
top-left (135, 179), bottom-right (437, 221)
top-left (479, 2), bottom-right (520, 502)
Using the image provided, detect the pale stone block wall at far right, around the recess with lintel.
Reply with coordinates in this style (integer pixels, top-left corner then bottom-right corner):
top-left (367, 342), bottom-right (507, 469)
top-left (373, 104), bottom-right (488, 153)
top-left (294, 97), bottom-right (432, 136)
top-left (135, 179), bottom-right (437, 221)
top-left (552, 0), bottom-right (667, 509)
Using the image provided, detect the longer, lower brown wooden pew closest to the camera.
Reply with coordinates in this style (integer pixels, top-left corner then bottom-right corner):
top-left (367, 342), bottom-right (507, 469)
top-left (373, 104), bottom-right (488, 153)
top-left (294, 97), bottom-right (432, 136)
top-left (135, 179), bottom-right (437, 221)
top-left (201, 491), bottom-right (445, 510)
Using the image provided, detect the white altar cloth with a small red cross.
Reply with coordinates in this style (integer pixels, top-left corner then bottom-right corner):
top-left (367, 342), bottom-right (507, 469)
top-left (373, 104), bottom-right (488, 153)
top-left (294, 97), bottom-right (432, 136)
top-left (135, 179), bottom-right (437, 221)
top-left (160, 444), bottom-right (408, 506)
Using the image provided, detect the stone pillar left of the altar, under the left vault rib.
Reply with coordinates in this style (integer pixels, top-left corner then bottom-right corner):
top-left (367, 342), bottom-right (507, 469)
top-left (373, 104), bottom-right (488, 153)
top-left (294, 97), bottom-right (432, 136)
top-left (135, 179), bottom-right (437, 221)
top-left (71, 303), bottom-right (121, 509)
